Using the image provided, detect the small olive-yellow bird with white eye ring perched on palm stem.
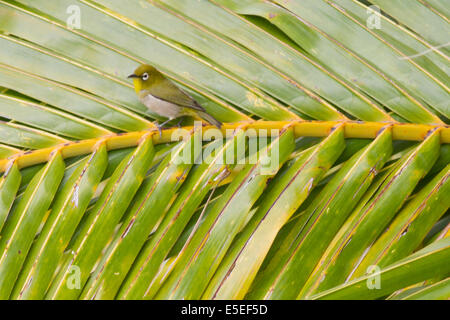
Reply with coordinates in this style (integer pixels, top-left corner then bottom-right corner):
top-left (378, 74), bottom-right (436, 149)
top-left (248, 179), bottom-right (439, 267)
top-left (128, 64), bottom-right (222, 135)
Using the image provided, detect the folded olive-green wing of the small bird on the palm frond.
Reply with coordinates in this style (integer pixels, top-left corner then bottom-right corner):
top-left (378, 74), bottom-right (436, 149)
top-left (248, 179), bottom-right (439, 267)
top-left (147, 78), bottom-right (205, 111)
